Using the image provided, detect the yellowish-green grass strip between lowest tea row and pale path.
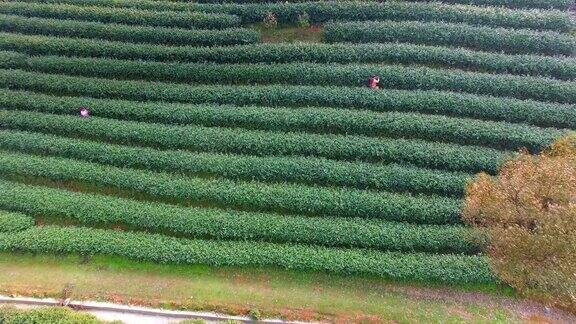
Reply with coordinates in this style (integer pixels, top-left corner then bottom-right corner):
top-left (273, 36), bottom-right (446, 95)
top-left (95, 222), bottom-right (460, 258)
top-left (0, 253), bottom-right (520, 323)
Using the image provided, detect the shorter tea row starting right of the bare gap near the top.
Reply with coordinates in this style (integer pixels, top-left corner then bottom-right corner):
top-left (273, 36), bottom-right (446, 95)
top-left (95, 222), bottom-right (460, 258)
top-left (324, 21), bottom-right (576, 56)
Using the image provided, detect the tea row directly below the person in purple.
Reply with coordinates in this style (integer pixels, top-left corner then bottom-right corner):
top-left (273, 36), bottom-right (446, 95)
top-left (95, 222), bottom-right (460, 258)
top-left (0, 110), bottom-right (507, 172)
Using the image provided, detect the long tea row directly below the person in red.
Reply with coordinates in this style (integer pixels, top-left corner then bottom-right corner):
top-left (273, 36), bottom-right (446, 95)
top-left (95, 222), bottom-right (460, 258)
top-left (0, 69), bottom-right (576, 129)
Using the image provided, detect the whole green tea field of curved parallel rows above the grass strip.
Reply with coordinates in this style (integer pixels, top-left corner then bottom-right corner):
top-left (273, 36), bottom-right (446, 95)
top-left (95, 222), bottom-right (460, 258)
top-left (0, 0), bottom-right (576, 290)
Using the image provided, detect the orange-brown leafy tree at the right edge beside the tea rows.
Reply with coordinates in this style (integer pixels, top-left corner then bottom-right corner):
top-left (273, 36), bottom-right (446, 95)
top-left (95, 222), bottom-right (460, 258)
top-left (464, 134), bottom-right (576, 311)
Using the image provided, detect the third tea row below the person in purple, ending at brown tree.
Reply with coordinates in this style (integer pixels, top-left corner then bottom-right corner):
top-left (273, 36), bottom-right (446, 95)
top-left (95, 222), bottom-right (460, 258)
top-left (0, 152), bottom-right (460, 224)
